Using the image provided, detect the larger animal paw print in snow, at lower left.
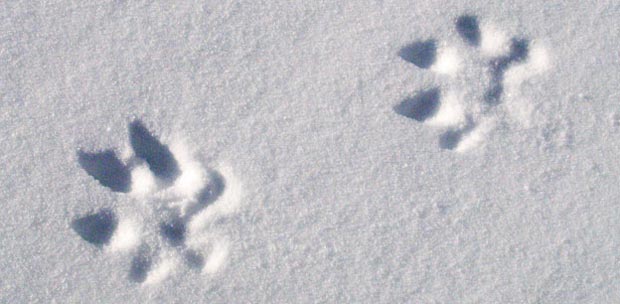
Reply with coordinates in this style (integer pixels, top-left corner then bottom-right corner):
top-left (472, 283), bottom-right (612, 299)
top-left (71, 120), bottom-right (241, 284)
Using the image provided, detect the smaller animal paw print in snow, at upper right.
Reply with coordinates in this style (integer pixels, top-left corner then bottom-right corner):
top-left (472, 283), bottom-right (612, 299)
top-left (394, 15), bottom-right (550, 152)
